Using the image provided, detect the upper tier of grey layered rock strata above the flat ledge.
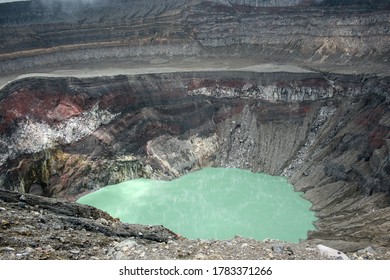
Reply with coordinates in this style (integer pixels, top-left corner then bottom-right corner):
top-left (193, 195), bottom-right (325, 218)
top-left (0, 0), bottom-right (390, 73)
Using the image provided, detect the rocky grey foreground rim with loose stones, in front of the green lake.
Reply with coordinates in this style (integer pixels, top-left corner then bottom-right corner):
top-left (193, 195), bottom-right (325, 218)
top-left (0, 191), bottom-right (390, 260)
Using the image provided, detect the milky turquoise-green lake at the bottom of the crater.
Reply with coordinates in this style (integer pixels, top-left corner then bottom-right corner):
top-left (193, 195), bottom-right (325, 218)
top-left (78, 168), bottom-right (315, 242)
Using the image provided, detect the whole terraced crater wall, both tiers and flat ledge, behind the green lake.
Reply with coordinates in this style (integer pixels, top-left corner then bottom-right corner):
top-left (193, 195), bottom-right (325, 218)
top-left (0, 0), bottom-right (390, 258)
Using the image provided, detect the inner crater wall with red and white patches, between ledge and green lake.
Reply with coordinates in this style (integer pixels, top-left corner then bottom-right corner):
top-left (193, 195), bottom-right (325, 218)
top-left (0, 71), bottom-right (390, 246)
